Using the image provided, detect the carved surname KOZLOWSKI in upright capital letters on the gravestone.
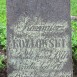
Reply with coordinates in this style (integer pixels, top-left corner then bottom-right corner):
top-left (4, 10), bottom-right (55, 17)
top-left (13, 38), bottom-right (65, 48)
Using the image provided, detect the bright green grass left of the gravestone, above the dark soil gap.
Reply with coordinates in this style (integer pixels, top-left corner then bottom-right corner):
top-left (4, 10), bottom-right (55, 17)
top-left (0, 0), bottom-right (6, 47)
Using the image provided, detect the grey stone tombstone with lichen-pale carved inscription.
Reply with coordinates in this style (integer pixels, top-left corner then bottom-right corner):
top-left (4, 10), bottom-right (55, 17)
top-left (7, 0), bottom-right (73, 77)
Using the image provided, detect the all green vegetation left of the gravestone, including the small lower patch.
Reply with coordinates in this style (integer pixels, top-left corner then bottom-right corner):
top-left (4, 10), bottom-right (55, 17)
top-left (0, 0), bottom-right (6, 70)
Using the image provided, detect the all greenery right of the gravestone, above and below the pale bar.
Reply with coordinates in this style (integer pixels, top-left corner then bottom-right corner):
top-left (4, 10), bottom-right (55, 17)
top-left (71, 0), bottom-right (77, 61)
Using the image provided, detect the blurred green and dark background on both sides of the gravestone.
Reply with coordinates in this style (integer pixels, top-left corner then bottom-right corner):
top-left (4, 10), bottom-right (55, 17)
top-left (0, 0), bottom-right (77, 77)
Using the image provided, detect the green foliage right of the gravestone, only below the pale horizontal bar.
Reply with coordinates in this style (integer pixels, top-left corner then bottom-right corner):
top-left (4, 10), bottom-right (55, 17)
top-left (71, 21), bottom-right (77, 61)
